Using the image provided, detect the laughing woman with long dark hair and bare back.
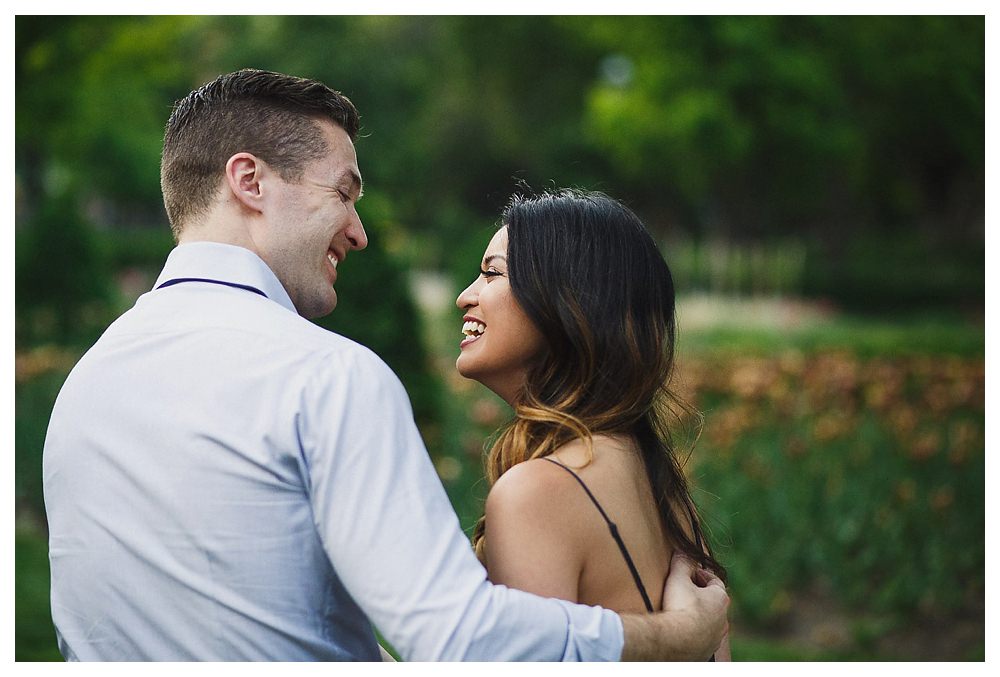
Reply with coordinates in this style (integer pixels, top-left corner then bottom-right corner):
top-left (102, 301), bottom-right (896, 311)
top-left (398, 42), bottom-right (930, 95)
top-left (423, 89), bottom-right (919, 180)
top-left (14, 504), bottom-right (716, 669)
top-left (456, 191), bottom-right (728, 658)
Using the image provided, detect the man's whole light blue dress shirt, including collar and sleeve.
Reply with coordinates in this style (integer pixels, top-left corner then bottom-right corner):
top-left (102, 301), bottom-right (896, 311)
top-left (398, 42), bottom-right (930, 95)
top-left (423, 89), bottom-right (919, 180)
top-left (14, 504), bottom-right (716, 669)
top-left (43, 243), bottom-right (623, 661)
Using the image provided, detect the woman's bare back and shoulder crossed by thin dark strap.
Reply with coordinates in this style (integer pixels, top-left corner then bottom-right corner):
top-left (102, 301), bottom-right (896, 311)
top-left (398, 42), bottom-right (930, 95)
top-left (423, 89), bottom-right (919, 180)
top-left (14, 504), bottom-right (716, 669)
top-left (485, 435), bottom-right (673, 612)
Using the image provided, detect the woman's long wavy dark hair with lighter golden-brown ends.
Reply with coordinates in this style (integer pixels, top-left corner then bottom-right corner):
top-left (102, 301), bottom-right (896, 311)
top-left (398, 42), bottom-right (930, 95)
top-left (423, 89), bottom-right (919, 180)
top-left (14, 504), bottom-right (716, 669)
top-left (473, 190), bottom-right (726, 580)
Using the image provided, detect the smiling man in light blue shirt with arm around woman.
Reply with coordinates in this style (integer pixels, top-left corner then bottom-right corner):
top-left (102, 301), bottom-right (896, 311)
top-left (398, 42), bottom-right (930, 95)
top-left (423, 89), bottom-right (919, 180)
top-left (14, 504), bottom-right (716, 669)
top-left (43, 70), bottom-right (728, 660)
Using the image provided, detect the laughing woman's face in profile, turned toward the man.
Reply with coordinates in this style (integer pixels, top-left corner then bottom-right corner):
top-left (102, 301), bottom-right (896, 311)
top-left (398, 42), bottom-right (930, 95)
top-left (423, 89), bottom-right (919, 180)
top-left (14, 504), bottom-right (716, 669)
top-left (455, 226), bottom-right (545, 405)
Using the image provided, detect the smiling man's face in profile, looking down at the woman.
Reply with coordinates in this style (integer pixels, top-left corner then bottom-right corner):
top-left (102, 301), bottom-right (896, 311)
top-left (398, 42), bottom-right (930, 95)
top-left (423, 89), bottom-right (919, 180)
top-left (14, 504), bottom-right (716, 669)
top-left (255, 121), bottom-right (368, 318)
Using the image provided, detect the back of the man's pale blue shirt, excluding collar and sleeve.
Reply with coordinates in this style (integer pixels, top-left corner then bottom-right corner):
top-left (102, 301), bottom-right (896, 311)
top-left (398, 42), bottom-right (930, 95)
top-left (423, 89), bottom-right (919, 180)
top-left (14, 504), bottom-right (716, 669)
top-left (44, 244), bottom-right (378, 660)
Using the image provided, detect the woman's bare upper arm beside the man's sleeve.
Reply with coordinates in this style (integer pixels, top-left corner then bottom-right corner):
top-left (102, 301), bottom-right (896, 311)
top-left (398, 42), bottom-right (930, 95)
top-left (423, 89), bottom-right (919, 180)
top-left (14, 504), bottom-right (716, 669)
top-left (485, 460), bottom-right (586, 602)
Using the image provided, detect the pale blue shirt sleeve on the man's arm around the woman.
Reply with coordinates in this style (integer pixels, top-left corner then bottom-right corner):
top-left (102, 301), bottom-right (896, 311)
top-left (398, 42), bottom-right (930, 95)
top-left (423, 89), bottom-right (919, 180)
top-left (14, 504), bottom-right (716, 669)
top-left (299, 347), bottom-right (623, 661)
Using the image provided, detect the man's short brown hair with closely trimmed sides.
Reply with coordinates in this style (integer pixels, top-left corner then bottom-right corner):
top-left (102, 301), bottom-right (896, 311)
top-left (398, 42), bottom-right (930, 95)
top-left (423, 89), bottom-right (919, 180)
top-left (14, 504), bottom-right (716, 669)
top-left (160, 69), bottom-right (359, 237)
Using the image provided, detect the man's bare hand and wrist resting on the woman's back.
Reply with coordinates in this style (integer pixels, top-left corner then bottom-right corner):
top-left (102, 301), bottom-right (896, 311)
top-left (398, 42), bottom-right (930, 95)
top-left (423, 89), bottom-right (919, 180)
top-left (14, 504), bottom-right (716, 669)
top-left (621, 554), bottom-right (729, 661)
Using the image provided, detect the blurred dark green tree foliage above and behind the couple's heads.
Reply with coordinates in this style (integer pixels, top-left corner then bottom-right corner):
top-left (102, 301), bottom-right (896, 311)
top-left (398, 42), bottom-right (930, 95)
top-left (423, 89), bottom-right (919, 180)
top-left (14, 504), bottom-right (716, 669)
top-left (15, 16), bottom-right (985, 312)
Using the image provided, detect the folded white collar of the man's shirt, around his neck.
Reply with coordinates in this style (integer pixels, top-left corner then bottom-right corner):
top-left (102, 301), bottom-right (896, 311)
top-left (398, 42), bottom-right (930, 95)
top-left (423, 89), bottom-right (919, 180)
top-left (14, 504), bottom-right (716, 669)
top-left (153, 242), bottom-right (297, 313)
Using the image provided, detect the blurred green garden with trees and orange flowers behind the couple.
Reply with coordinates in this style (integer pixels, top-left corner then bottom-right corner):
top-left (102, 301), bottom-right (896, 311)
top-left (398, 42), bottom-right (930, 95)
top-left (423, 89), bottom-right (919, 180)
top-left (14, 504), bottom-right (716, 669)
top-left (15, 16), bottom-right (985, 660)
